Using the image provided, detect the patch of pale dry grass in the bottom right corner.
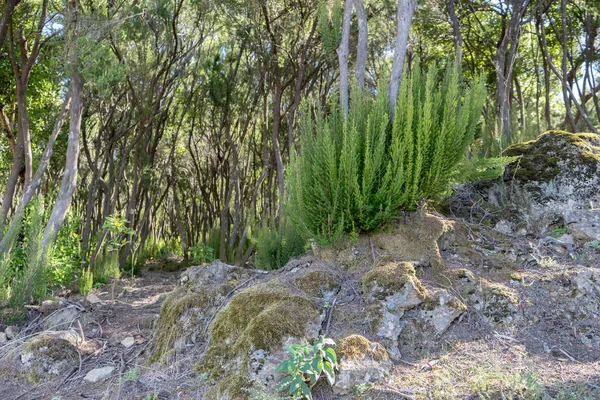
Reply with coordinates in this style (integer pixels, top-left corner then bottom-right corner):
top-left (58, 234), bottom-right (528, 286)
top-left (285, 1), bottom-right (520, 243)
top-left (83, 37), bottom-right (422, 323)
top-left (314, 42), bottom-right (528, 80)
top-left (378, 339), bottom-right (600, 400)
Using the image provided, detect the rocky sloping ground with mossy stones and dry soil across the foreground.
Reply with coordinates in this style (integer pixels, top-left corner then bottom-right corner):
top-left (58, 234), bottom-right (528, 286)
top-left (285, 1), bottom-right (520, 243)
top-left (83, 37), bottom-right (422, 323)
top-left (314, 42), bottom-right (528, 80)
top-left (0, 133), bottom-right (600, 400)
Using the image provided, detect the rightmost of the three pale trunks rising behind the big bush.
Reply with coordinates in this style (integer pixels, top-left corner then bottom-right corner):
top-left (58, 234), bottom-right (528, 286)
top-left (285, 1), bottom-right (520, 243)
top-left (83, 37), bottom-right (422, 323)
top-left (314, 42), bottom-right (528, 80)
top-left (388, 0), bottom-right (418, 118)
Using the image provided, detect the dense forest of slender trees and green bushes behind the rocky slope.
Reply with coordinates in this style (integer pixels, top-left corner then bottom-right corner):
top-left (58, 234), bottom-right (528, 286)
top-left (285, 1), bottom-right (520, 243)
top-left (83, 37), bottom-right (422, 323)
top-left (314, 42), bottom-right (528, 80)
top-left (0, 0), bottom-right (600, 398)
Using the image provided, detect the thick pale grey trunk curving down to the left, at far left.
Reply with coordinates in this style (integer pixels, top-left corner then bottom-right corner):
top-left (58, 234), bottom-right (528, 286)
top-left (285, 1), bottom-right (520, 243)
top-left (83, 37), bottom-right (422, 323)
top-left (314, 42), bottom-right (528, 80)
top-left (42, 72), bottom-right (83, 247)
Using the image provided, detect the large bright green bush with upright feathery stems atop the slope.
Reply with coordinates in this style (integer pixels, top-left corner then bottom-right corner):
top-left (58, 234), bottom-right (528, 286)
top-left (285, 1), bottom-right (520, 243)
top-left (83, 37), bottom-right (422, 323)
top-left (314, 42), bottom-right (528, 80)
top-left (288, 63), bottom-right (485, 243)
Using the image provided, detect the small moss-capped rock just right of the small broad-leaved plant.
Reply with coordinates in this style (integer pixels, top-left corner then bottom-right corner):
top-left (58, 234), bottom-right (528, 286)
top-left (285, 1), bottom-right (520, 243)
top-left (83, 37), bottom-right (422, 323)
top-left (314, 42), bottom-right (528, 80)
top-left (333, 335), bottom-right (392, 394)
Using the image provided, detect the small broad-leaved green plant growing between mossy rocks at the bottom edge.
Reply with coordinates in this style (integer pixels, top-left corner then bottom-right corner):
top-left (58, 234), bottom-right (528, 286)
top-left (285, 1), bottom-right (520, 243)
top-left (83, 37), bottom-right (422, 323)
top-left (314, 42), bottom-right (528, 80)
top-left (277, 336), bottom-right (339, 400)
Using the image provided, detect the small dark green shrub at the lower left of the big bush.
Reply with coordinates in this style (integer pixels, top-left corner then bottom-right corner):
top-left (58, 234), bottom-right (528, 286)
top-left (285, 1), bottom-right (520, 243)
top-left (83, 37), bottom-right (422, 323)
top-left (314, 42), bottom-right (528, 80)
top-left (254, 219), bottom-right (306, 270)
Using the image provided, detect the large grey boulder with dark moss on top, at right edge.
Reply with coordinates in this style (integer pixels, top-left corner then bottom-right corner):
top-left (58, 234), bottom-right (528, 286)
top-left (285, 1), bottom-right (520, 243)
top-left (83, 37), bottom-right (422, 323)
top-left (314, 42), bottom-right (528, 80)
top-left (502, 131), bottom-right (600, 239)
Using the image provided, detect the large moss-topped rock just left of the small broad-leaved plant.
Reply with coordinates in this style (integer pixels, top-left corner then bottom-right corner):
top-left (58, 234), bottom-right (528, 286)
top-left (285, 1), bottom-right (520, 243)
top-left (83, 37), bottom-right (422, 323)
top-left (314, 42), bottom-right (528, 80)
top-left (196, 281), bottom-right (319, 398)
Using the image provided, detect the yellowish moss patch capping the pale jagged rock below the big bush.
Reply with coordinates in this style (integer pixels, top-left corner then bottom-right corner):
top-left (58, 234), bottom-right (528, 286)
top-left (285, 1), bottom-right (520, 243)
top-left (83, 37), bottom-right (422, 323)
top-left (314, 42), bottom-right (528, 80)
top-left (362, 257), bottom-right (428, 300)
